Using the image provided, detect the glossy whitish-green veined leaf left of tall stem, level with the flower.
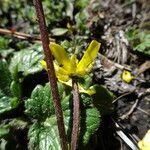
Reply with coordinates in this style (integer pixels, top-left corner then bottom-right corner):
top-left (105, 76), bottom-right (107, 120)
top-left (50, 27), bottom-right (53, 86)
top-left (10, 44), bottom-right (44, 80)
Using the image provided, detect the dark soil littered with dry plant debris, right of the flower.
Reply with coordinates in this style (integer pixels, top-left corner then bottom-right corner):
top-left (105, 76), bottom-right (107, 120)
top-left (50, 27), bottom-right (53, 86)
top-left (91, 0), bottom-right (150, 150)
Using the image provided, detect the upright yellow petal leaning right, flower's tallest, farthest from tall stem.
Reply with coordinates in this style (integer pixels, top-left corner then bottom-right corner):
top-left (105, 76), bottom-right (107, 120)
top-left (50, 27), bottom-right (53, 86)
top-left (77, 40), bottom-right (101, 74)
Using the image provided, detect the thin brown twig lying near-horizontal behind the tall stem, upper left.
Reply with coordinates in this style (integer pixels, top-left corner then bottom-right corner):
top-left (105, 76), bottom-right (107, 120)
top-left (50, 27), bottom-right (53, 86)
top-left (0, 28), bottom-right (55, 42)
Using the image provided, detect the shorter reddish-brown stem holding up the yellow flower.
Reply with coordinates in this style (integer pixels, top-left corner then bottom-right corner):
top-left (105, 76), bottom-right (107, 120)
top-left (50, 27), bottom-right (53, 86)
top-left (71, 79), bottom-right (80, 150)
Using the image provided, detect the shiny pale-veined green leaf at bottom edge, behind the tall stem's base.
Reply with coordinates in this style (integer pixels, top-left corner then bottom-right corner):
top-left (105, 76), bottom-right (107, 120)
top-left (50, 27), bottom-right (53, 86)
top-left (28, 111), bottom-right (70, 150)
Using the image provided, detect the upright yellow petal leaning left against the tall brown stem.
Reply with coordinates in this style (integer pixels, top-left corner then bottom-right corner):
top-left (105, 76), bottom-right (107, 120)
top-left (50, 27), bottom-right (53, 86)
top-left (49, 43), bottom-right (72, 70)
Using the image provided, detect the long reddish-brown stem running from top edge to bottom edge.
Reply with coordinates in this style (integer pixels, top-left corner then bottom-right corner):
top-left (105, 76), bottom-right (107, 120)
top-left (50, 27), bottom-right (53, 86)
top-left (33, 0), bottom-right (67, 150)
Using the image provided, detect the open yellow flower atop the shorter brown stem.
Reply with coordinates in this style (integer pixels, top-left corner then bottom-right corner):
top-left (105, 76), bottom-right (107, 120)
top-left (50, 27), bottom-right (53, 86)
top-left (40, 40), bottom-right (101, 95)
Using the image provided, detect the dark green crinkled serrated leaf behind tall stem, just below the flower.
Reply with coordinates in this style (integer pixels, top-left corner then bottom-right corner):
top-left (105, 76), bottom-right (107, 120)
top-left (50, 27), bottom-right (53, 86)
top-left (25, 83), bottom-right (70, 120)
